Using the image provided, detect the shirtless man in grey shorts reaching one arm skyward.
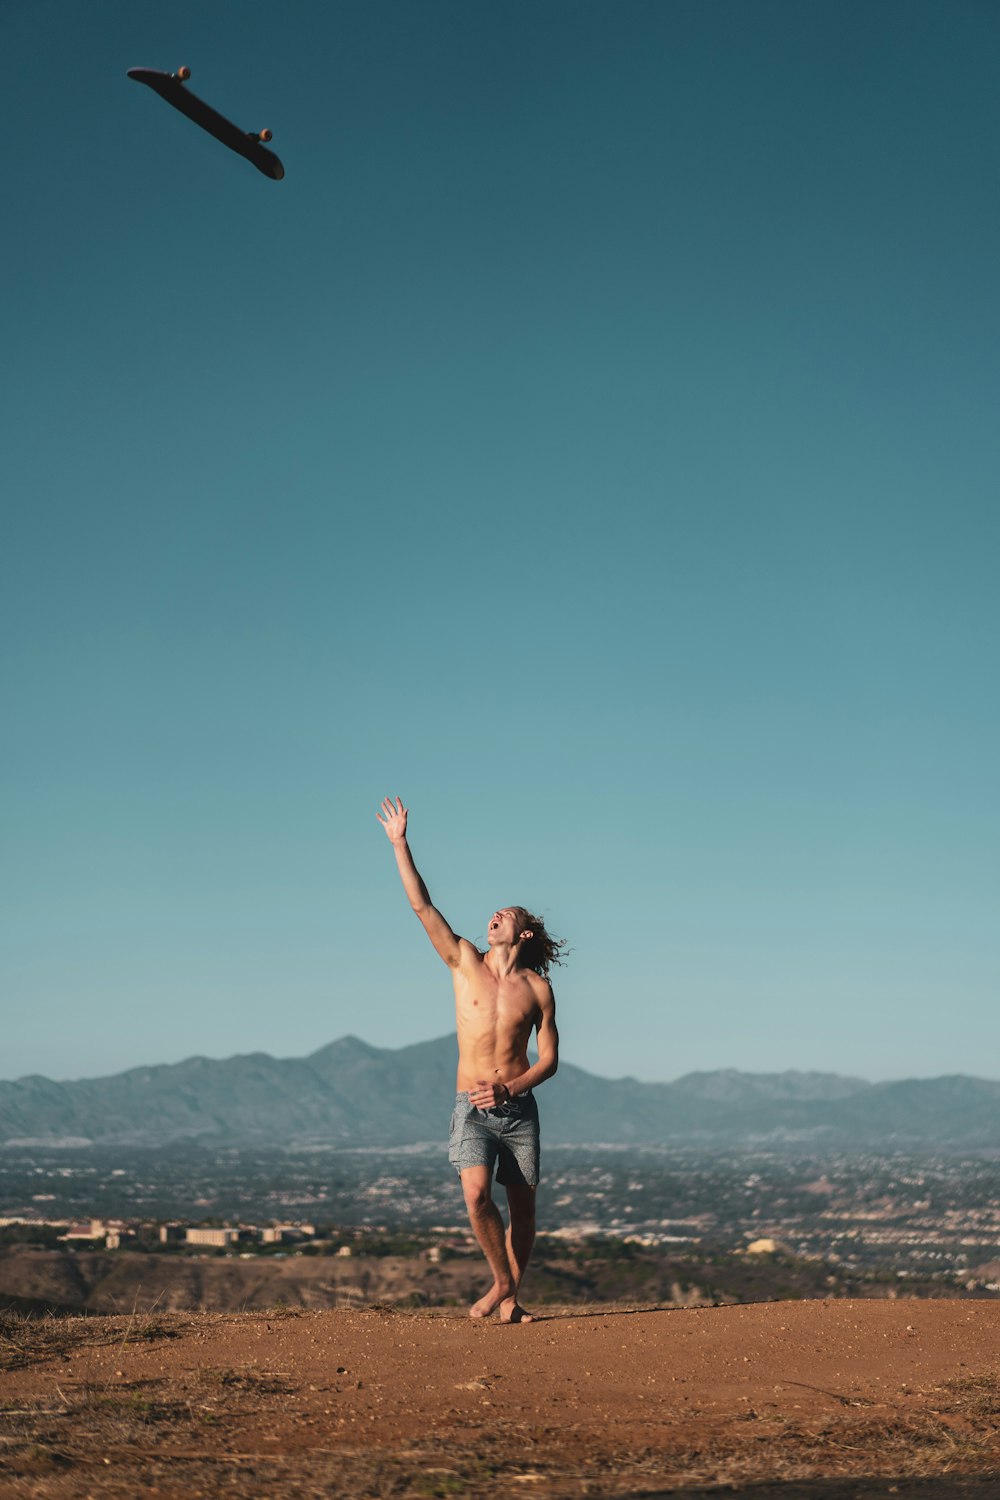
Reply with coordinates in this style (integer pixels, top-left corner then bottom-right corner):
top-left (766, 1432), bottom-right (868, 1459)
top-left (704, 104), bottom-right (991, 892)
top-left (375, 798), bottom-right (564, 1323)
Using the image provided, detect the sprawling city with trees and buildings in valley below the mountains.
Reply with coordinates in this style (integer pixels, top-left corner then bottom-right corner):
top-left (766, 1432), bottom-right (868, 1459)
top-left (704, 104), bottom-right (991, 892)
top-left (0, 1145), bottom-right (1000, 1301)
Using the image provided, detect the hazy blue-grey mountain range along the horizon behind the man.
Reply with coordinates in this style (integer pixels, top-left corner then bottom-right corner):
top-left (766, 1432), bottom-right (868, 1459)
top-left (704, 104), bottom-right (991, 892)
top-left (0, 1037), bottom-right (1000, 1151)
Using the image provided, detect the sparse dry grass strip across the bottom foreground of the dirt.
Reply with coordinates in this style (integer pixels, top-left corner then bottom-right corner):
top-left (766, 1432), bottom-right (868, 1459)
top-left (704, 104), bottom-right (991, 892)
top-left (0, 1368), bottom-right (1000, 1500)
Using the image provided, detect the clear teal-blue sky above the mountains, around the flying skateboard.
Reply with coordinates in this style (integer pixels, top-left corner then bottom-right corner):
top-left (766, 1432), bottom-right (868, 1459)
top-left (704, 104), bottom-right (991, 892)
top-left (0, 0), bottom-right (1000, 1079)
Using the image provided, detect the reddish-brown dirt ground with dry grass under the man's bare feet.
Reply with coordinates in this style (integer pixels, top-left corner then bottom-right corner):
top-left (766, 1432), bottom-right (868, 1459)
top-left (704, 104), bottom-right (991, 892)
top-left (0, 1301), bottom-right (1000, 1500)
